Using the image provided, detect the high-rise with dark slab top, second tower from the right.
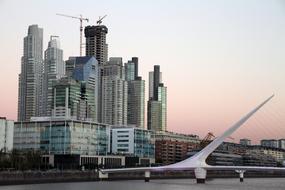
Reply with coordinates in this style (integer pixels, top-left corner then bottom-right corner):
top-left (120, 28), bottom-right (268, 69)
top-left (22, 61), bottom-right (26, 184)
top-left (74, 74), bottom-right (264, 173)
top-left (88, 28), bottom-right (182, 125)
top-left (125, 57), bottom-right (145, 128)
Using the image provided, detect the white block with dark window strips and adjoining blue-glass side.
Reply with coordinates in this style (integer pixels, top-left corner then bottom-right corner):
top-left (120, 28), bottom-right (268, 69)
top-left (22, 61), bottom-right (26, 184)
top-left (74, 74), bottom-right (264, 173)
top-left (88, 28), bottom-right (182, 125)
top-left (111, 126), bottom-right (155, 166)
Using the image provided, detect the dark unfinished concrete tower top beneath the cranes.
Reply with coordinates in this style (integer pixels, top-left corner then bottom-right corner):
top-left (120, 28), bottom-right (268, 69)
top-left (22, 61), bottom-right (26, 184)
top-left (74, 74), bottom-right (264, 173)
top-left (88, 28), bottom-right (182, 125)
top-left (84, 25), bottom-right (108, 65)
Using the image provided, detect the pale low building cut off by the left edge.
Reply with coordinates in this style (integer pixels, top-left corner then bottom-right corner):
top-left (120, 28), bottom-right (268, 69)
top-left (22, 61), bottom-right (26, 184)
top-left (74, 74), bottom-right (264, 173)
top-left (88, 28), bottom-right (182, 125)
top-left (0, 117), bottom-right (14, 153)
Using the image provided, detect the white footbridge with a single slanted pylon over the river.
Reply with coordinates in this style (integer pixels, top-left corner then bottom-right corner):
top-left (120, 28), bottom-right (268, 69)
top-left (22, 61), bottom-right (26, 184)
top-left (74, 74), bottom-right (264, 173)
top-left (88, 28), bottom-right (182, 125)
top-left (99, 95), bottom-right (285, 183)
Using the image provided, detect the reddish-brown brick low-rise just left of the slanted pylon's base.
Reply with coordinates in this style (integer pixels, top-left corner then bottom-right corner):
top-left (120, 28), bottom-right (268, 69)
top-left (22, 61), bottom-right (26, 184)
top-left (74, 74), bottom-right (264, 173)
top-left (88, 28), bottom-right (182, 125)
top-left (155, 131), bottom-right (200, 165)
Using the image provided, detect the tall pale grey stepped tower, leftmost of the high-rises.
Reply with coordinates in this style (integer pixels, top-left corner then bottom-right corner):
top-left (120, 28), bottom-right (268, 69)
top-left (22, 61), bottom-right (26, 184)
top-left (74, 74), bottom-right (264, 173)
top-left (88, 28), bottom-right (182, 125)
top-left (18, 25), bottom-right (43, 121)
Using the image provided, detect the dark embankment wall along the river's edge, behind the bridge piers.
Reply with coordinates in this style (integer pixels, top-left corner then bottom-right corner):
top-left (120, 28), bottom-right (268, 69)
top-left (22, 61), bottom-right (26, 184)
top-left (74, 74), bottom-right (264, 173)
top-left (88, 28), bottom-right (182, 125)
top-left (0, 171), bottom-right (285, 185)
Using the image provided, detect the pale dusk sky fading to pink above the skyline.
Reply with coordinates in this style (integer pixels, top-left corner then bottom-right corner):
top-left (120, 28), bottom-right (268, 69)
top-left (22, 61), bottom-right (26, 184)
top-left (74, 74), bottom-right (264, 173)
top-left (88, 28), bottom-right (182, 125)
top-left (0, 0), bottom-right (285, 142)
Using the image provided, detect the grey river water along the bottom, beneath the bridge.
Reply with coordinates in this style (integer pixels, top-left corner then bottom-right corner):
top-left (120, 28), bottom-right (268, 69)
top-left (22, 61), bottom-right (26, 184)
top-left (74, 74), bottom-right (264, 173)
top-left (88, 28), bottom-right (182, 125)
top-left (0, 178), bottom-right (285, 190)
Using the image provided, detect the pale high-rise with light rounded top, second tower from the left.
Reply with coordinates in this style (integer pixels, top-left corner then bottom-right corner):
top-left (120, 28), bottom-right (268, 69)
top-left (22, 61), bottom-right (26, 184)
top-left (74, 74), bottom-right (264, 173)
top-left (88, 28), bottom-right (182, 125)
top-left (41, 36), bottom-right (65, 116)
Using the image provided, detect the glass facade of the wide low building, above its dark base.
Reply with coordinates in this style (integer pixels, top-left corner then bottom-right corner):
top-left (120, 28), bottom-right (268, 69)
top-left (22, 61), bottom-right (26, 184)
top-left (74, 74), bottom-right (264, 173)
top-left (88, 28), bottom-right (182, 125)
top-left (14, 120), bottom-right (109, 155)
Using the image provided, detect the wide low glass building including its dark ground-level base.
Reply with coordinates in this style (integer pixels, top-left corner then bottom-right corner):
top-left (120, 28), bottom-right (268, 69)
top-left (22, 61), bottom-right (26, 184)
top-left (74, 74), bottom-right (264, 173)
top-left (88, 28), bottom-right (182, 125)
top-left (14, 117), bottom-right (134, 169)
